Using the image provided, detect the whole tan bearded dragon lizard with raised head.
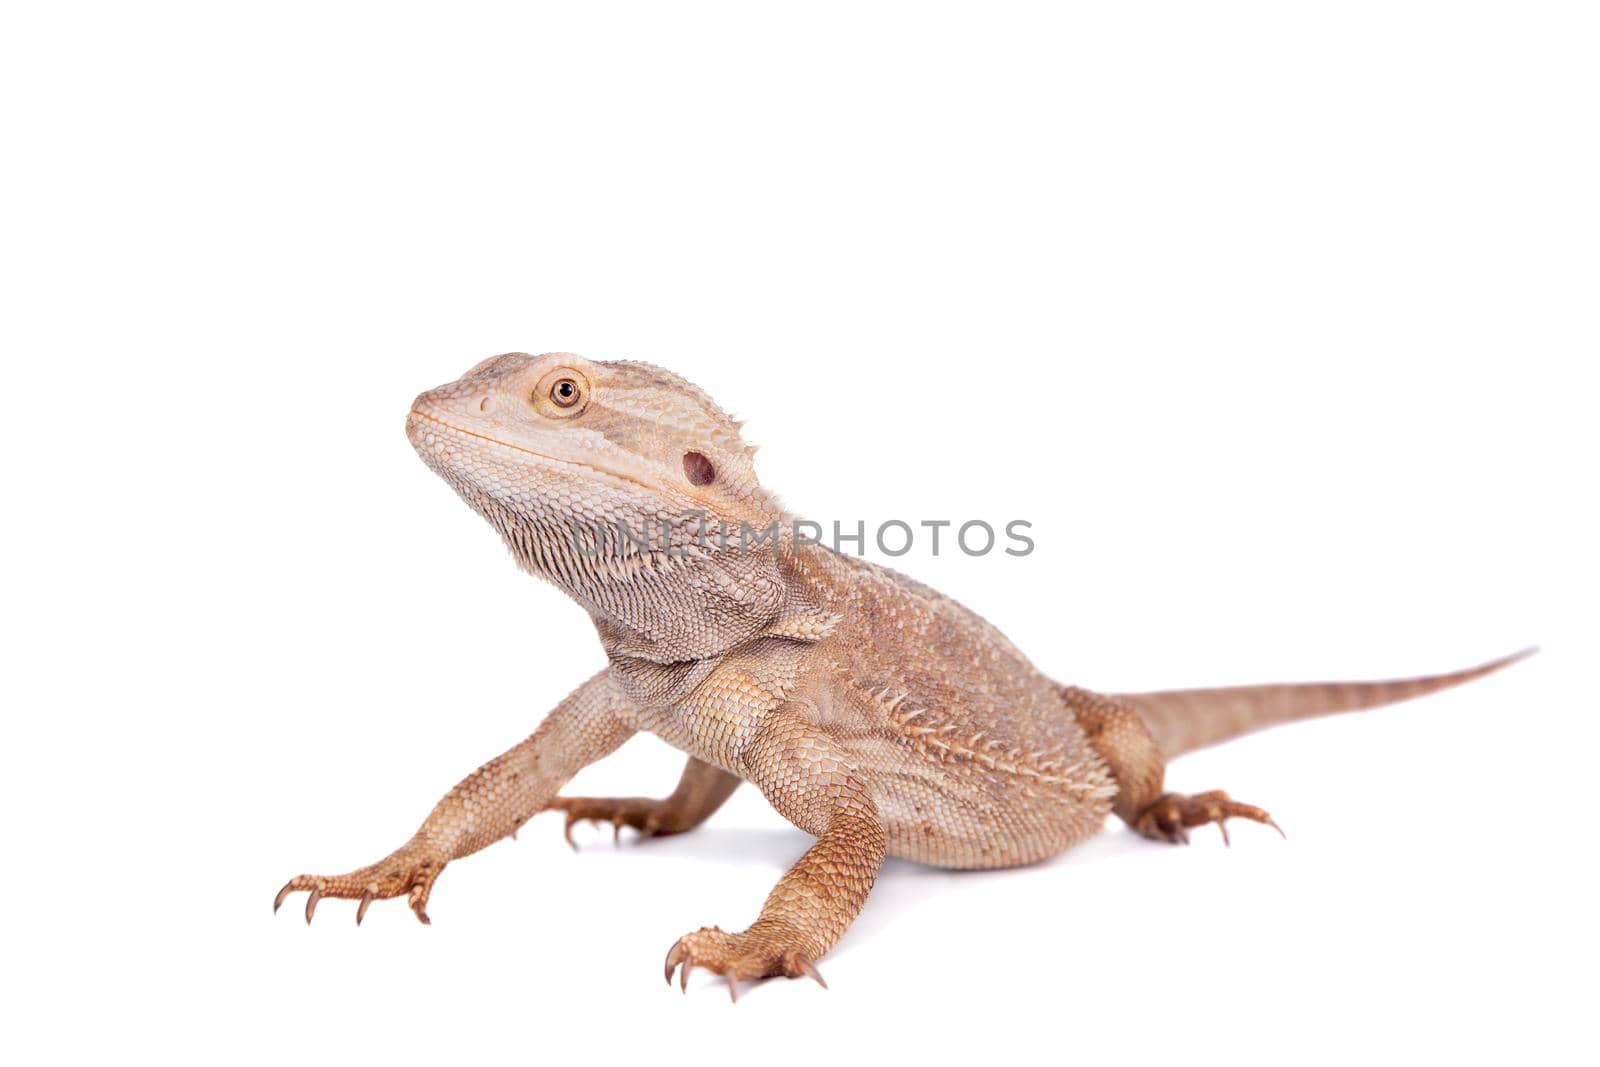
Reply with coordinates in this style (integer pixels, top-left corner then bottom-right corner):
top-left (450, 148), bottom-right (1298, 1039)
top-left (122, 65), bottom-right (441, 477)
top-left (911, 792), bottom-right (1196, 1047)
top-left (274, 352), bottom-right (1533, 998)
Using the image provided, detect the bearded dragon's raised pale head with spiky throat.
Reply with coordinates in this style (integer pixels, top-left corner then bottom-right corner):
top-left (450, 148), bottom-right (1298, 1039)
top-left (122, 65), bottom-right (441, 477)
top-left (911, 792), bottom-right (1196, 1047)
top-left (406, 352), bottom-right (782, 657)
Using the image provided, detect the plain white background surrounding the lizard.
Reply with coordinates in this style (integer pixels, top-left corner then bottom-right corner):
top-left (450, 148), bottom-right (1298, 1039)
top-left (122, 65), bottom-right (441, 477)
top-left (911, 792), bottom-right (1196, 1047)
top-left (0, 3), bottom-right (1600, 1067)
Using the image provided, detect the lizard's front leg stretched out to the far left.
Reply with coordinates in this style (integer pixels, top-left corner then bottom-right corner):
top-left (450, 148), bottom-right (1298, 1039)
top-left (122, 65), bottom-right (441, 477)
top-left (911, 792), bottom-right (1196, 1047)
top-left (272, 672), bottom-right (634, 923)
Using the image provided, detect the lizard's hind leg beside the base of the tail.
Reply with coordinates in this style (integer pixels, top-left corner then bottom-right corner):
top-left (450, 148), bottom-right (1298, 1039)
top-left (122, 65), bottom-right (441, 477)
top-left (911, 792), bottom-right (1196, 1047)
top-left (1061, 688), bottom-right (1283, 845)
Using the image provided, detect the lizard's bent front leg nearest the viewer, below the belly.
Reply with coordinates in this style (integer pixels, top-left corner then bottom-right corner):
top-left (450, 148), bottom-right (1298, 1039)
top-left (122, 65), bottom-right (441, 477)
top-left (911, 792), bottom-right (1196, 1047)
top-left (666, 710), bottom-right (888, 998)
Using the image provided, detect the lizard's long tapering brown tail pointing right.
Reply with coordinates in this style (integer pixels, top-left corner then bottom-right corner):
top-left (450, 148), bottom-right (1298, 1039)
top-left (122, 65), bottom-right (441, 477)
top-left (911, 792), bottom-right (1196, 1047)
top-left (1117, 648), bottom-right (1539, 760)
